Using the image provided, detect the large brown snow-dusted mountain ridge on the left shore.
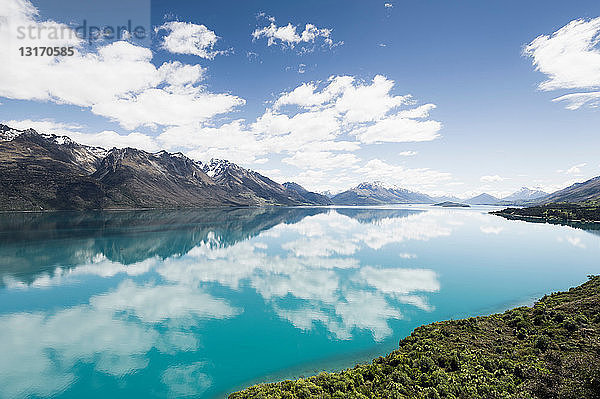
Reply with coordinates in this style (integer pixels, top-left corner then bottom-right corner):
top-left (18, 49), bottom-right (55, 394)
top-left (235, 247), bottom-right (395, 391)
top-left (0, 125), bottom-right (323, 210)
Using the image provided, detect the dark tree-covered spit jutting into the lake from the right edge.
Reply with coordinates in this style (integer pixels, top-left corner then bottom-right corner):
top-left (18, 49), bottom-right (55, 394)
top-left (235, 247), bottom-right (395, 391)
top-left (491, 203), bottom-right (600, 222)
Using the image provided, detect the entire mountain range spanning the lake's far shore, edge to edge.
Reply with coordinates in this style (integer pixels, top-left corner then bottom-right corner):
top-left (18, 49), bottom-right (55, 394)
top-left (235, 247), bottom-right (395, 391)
top-left (0, 124), bottom-right (600, 210)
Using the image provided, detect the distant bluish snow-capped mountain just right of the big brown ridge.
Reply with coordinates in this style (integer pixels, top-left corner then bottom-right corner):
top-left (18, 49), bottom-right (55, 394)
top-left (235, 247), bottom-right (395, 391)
top-left (331, 182), bottom-right (435, 205)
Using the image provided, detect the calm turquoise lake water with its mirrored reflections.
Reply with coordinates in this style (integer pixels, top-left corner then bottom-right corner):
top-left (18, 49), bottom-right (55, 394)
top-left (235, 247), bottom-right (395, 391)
top-left (0, 206), bottom-right (600, 398)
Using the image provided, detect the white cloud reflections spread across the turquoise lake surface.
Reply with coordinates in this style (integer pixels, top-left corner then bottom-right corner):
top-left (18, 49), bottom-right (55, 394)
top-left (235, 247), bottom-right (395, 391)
top-left (0, 210), bottom-right (452, 398)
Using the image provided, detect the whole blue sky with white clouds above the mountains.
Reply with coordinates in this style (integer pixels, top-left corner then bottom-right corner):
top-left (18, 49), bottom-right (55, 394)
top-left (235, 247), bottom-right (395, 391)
top-left (0, 0), bottom-right (600, 197)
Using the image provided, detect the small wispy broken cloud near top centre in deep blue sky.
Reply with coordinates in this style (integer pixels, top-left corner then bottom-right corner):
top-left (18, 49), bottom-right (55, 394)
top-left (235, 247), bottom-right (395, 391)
top-left (252, 17), bottom-right (342, 51)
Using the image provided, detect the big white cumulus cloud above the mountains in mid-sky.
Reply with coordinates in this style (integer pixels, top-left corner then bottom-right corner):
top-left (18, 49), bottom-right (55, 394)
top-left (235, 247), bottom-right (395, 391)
top-left (156, 75), bottom-right (441, 179)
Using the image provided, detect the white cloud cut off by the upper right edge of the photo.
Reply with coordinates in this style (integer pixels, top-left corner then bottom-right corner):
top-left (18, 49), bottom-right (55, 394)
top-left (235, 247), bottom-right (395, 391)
top-left (524, 17), bottom-right (600, 109)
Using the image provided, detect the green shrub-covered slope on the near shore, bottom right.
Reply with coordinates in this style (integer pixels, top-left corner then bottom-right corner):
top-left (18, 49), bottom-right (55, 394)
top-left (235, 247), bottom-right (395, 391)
top-left (229, 276), bottom-right (600, 399)
